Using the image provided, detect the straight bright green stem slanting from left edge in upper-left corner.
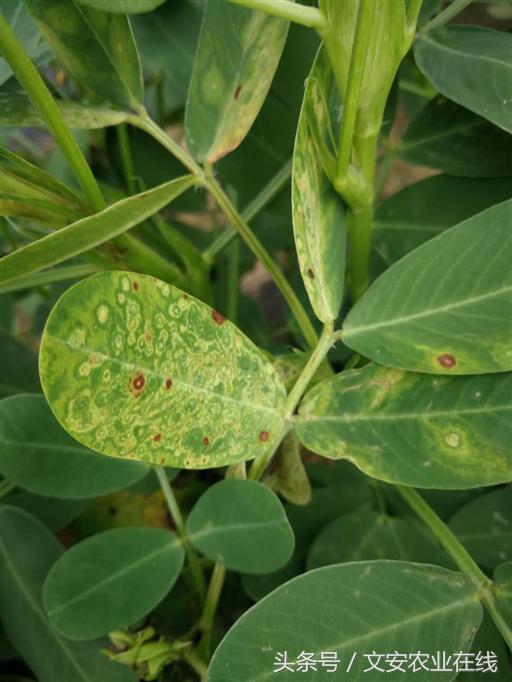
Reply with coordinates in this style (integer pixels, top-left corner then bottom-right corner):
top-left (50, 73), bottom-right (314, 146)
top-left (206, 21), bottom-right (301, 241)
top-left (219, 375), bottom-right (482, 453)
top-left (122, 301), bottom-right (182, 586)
top-left (0, 15), bottom-right (105, 211)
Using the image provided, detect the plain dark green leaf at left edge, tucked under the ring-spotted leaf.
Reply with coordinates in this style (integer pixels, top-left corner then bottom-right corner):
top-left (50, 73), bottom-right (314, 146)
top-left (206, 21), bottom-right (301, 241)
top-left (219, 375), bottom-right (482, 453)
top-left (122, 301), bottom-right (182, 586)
top-left (0, 395), bottom-right (147, 499)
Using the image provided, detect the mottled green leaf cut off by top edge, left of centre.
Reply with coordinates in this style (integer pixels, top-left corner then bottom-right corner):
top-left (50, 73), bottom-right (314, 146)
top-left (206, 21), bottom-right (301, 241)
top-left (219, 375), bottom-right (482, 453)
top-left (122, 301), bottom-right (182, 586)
top-left (25, 0), bottom-right (144, 108)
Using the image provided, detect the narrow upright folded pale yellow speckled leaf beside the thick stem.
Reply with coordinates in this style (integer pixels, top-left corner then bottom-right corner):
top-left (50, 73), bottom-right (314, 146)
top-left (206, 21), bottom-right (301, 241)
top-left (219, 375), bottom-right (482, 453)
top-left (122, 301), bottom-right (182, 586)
top-left (292, 48), bottom-right (347, 323)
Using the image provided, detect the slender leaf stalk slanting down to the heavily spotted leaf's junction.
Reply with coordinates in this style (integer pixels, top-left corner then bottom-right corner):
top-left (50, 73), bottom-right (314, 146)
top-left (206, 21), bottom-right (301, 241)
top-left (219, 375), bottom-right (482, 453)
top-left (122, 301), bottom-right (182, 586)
top-left (131, 115), bottom-right (318, 348)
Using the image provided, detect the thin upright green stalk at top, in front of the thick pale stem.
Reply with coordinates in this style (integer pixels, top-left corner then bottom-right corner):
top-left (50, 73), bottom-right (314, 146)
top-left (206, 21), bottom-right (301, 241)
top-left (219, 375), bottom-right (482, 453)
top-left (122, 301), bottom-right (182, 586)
top-left (336, 0), bottom-right (375, 186)
